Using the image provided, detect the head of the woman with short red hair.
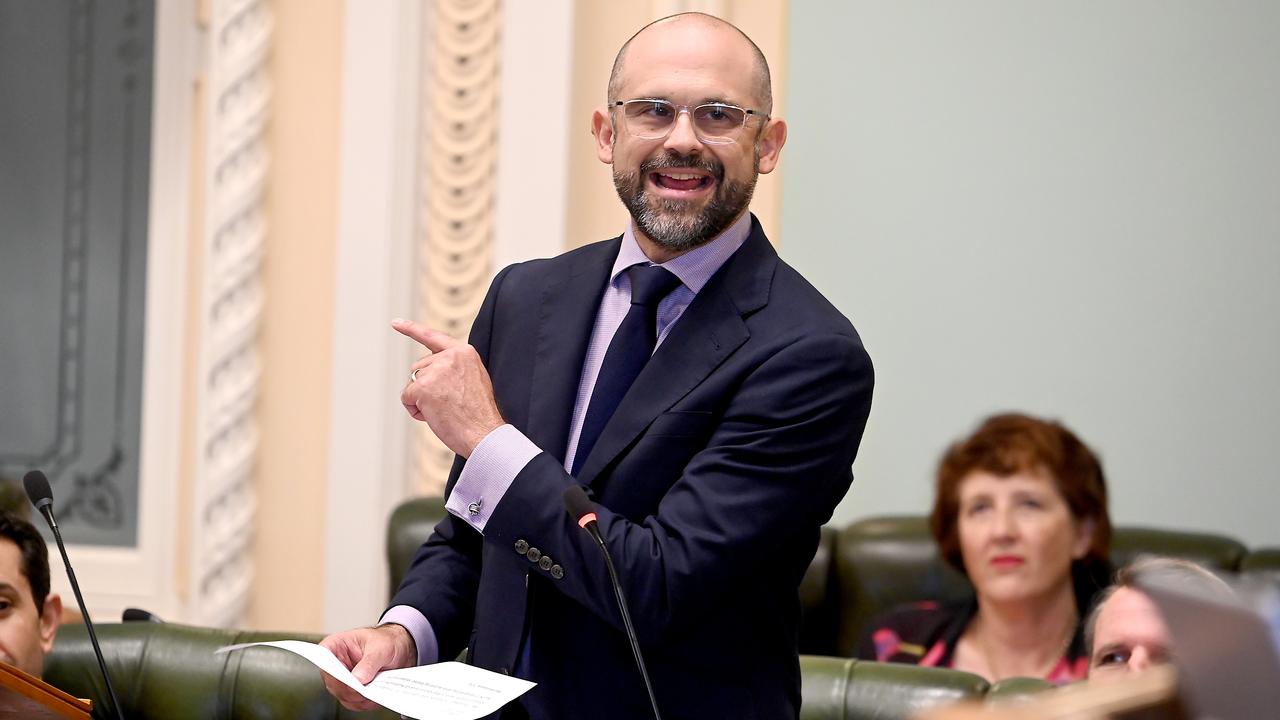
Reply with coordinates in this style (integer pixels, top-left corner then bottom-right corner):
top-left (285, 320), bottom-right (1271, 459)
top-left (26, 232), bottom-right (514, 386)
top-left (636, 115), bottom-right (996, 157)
top-left (929, 414), bottom-right (1111, 612)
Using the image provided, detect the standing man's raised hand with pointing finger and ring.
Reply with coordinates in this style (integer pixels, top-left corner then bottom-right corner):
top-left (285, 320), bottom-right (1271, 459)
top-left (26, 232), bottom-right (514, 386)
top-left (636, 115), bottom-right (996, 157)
top-left (392, 320), bottom-right (504, 457)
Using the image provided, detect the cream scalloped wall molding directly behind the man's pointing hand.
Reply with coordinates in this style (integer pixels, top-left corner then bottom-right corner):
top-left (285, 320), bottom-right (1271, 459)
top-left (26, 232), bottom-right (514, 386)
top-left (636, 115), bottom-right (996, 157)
top-left (415, 0), bottom-right (502, 493)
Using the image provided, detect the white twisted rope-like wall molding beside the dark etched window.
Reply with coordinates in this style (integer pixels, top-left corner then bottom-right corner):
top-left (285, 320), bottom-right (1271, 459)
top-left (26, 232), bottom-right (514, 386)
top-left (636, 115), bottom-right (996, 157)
top-left (188, 0), bottom-right (273, 625)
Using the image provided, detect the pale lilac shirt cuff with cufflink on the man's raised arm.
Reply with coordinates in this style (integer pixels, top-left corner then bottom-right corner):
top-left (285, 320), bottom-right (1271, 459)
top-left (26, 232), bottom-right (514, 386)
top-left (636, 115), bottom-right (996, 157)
top-left (444, 424), bottom-right (541, 534)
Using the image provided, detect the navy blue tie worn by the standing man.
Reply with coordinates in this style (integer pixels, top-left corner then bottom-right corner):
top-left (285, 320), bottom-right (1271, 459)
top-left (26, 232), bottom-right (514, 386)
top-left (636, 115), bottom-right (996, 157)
top-left (572, 265), bottom-right (680, 477)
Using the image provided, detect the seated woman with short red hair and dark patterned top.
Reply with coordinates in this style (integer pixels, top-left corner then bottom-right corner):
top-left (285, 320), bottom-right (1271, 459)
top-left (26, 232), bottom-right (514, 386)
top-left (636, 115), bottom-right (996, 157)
top-left (856, 414), bottom-right (1111, 684)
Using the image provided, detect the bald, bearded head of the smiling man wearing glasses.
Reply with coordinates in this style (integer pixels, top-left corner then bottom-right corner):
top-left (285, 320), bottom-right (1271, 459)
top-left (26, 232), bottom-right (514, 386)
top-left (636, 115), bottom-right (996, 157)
top-left (591, 13), bottom-right (787, 258)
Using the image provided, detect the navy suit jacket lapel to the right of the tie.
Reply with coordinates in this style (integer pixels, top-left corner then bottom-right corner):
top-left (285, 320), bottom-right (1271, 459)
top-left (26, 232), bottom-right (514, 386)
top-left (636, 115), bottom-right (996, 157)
top-left (579, 218), bottom-right (778, 484)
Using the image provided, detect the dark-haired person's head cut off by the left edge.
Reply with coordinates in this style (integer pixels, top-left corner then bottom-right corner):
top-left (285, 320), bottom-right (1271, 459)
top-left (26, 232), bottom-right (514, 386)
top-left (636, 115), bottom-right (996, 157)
top-left (0, 511), bottom-right (63, 676)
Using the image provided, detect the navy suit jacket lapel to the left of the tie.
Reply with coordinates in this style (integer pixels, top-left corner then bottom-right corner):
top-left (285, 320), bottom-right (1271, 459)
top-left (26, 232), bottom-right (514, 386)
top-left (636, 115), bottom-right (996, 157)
top-left (524, 238), bottom-right (621, 462)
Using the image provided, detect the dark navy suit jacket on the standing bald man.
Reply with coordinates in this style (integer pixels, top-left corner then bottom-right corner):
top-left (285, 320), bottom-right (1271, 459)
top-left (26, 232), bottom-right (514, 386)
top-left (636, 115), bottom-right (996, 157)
top-left (390, 218), bottom-right (873, 720)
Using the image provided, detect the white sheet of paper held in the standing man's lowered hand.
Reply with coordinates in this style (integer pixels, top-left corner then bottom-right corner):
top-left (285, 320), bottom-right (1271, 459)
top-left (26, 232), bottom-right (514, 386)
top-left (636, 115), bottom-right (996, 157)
top-left (216, 641), bottom-right (534, 720)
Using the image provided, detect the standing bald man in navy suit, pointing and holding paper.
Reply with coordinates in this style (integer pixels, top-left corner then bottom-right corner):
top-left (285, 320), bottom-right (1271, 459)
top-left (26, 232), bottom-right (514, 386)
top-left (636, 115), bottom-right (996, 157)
top-left (324, 13), bottom-right (873, 720)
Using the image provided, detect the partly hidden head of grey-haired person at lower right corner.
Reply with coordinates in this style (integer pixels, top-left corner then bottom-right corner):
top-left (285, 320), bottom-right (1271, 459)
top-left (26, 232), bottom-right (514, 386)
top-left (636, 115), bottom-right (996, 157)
top-left (1084, 557), bottom-right (1233, 682)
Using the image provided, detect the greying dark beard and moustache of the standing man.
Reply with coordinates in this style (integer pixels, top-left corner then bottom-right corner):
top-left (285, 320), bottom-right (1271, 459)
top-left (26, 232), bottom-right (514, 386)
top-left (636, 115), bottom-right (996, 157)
top-left (613, 152), bottom-right (759, 252)
